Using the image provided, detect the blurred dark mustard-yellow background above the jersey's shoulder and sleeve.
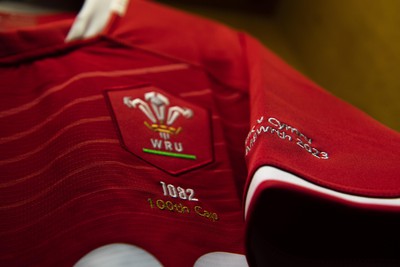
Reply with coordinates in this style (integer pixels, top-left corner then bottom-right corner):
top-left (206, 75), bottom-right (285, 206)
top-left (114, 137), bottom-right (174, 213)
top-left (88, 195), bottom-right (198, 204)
top-left (158, 0), bottom-right (400, 131)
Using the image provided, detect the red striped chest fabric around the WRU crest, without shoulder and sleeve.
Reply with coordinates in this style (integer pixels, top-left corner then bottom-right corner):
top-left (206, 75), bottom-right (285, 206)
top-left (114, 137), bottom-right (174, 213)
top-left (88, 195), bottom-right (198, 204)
top-left (0, 2), bottom-right (248, 266)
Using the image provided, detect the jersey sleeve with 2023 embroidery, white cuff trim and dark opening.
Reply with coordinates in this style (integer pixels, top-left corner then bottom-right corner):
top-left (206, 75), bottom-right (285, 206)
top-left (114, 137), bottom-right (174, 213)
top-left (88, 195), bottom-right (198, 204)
top-left (244, 36), bottom-right (400, 266)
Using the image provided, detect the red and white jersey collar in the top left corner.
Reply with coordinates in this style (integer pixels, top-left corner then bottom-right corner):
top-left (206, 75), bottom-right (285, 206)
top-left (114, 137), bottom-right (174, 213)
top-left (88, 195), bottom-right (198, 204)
top-left (0, 0), bottom-right (129, 64)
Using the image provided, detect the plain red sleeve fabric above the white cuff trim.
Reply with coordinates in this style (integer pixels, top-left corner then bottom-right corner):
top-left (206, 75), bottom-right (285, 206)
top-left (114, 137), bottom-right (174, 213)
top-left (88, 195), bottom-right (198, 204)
top-left (246, 38), bottom-right (400, 197)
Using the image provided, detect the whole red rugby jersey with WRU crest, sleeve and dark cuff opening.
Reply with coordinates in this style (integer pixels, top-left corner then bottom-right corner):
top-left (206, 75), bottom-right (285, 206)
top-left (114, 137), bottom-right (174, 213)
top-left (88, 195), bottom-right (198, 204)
top-left (0, 1), bottom-right (400, 266)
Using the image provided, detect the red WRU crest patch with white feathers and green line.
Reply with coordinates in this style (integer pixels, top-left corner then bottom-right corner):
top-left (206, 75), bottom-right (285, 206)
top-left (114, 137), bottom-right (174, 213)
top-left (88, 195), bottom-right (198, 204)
top-left (108, 87), bottom-right (212, 174)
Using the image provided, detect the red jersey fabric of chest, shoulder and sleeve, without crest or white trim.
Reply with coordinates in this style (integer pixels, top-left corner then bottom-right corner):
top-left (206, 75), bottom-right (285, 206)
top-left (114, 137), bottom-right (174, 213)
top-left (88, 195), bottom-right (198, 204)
top-left (0, 1), bottom-right (400, 267)
